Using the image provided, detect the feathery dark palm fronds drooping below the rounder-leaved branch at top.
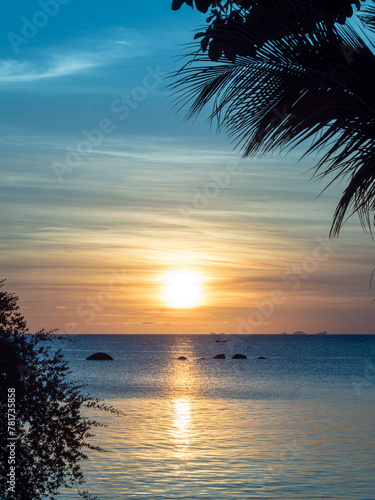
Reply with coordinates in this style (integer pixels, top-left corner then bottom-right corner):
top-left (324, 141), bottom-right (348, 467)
top-left (170, 23), bottom-right (375, 236)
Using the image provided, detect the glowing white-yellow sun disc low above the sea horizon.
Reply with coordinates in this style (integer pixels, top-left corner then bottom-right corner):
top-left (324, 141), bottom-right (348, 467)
top-left (163, 271), bottom-right (203, 307)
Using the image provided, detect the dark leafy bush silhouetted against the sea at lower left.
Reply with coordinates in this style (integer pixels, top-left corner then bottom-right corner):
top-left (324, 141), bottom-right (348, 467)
top-left (0, 280), bottom-right (121, 500)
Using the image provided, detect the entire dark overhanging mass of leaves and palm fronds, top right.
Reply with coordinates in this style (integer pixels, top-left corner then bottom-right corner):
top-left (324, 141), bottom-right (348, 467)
top-left (170, 0), bottom-right (375, 236)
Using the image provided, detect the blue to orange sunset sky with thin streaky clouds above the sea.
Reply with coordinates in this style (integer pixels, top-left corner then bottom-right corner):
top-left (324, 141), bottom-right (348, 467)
top-left (0, 0), bottom-right (375, 334)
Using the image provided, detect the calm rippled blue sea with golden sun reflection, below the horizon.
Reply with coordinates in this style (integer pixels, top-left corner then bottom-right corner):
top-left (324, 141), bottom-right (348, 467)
top-left (53, 335), bottom-right (375, 500)
